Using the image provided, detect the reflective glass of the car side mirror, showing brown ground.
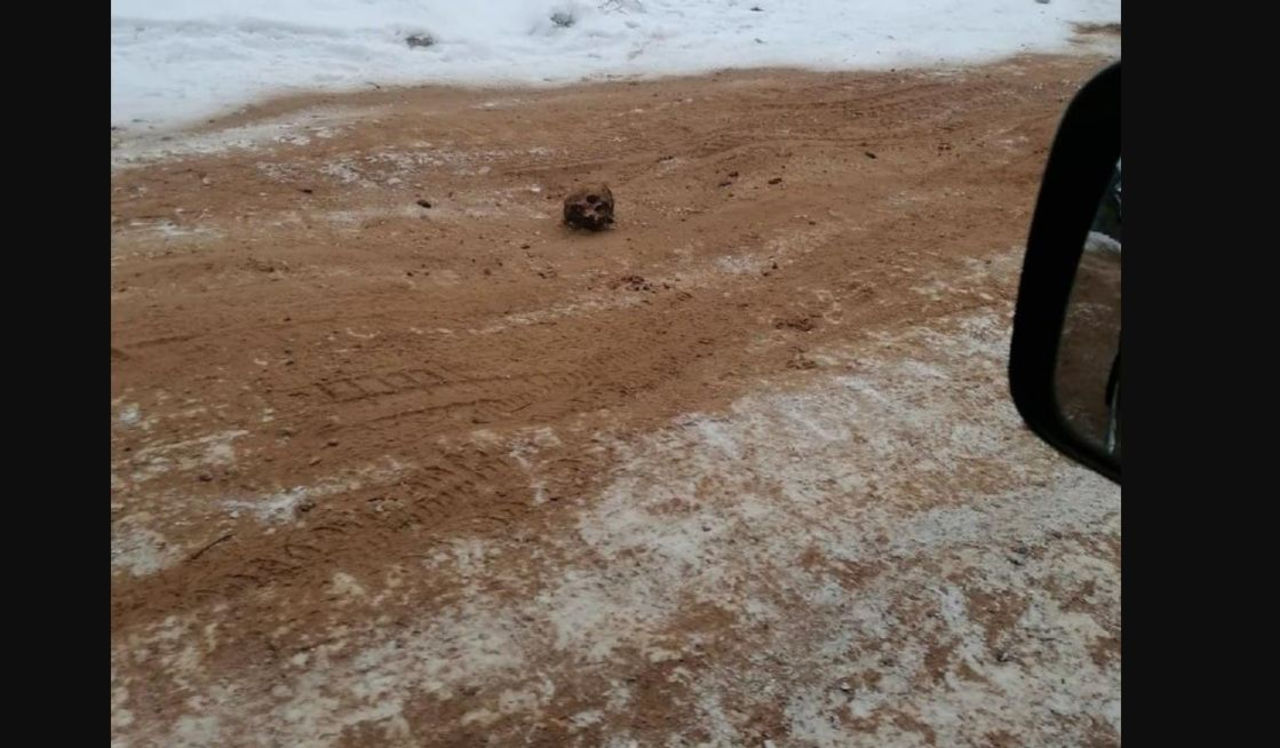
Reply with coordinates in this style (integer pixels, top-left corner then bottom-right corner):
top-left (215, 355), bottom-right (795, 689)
top-left (1055, 161), bottom-right (1120, 460)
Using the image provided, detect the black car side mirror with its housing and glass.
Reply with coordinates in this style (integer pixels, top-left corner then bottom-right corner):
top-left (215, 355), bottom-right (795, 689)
top-left (1009, 63), bottom-right (1121, 483)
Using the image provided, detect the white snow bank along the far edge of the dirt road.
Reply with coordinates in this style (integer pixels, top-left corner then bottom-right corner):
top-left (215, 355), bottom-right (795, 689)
top-left (111, 0), bottom-right (1120, 128)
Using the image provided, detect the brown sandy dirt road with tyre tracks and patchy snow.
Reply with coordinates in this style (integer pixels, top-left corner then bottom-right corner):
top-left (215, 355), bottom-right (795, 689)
top-left (111, 48), bottom-right (1120, 747)
